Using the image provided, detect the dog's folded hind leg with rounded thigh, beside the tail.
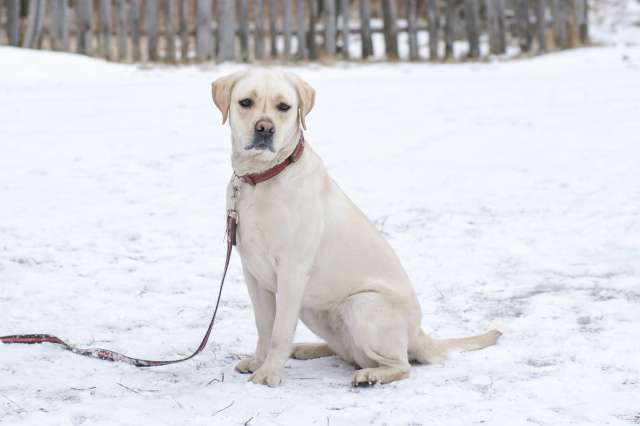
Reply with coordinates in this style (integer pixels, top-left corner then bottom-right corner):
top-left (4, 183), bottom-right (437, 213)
top-left (343, 292), bottom-right (411, 386)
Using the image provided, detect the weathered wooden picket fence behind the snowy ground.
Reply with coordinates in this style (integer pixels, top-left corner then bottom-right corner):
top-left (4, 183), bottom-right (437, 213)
top-left (0, 0), bottom-right (588, 63)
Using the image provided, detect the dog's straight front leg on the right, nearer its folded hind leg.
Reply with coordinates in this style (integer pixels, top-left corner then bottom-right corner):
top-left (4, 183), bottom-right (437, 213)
top-left (251, 265), bottom-right (309, 386)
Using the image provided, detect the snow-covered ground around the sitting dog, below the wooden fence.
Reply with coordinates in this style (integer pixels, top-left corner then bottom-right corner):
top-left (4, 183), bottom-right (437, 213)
top-left (0, 41), bottom-right (640, 425)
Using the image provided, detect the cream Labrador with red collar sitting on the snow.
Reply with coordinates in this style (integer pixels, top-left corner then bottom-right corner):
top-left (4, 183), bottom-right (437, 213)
top-left (212, 68), bottom-right (501, 386)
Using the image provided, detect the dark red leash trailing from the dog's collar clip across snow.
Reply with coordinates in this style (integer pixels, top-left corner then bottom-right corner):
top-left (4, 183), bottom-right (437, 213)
top-left (0, 215), bottom-right (237, 367)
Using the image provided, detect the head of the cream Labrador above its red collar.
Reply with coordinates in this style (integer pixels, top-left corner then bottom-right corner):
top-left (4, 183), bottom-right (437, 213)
top-left (212, 68), bottom-right (315, 162)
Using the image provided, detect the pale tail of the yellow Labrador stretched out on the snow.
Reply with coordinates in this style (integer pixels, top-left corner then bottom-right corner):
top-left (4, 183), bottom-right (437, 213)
top-left (409, 330), bottom-right (502, 364)
